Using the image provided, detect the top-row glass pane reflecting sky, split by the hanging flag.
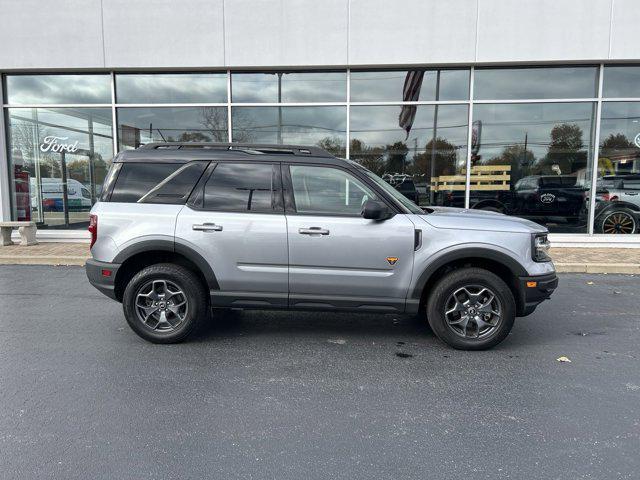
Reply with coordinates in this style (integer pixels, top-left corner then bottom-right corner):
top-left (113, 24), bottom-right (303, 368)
top-left (351, 70), bottom-right (469, 102)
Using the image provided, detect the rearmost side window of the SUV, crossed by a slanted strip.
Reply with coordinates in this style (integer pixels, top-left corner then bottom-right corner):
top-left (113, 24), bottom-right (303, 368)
top-left (110, 162), bottom-right (207, 204)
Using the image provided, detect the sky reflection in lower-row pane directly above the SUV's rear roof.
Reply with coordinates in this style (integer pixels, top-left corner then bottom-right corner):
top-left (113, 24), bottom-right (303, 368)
top-left (117, 107), bottom-right (228, 146)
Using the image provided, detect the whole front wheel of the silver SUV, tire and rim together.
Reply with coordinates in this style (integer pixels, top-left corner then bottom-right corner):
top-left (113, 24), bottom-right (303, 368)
top-left (427, 268), bottom-right (516, 350)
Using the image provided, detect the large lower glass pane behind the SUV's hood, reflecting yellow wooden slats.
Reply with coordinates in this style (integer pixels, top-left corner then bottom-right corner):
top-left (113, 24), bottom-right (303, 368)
top-left (470, 103), bottom-right (595, 233)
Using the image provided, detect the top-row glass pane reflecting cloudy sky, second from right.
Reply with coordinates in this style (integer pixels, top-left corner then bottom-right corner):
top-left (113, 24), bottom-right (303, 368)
top-left (473, 67), bottom-right (598, 100)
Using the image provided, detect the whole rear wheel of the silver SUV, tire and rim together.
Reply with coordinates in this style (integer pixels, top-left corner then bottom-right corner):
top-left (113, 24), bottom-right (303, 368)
top-left (122, 263), bottom-right (209, 343)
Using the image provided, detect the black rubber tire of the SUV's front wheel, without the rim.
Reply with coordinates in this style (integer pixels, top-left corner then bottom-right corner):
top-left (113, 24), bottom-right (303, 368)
top-left (427, 268), bottom-right (515, 350)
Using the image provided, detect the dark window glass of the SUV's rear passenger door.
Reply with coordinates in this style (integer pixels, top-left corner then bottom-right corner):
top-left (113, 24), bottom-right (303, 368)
top-left (202, 163), bottom-right (279, 213)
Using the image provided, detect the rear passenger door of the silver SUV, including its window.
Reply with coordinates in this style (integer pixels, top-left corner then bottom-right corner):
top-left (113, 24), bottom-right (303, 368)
top-left (176, 162), bottom-right (288, 307)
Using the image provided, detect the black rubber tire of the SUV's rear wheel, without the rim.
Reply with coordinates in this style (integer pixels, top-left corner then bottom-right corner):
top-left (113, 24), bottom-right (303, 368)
top-left (122, 264), bottom-right (206, 343)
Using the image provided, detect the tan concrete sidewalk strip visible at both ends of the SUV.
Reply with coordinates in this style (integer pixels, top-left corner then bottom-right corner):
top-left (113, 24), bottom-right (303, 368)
top-left (0, 243), bottom-right (640, 274)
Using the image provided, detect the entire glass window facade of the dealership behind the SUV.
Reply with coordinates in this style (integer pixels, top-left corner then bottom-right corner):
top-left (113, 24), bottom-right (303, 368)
top-left (2, 65), bottom-right (640, 234)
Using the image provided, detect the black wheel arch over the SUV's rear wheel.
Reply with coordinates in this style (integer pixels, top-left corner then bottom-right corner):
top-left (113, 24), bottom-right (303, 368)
top-left (113, 240), bottom-right (220, 302)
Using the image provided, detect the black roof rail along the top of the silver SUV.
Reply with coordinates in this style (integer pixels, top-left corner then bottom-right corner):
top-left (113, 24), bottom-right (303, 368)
top-left (139, 142), bottom-right (333, 157)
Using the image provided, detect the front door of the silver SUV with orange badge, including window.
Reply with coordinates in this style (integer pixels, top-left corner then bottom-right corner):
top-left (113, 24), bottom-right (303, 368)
top-left (283, 165), bottom-right (414, 311)
